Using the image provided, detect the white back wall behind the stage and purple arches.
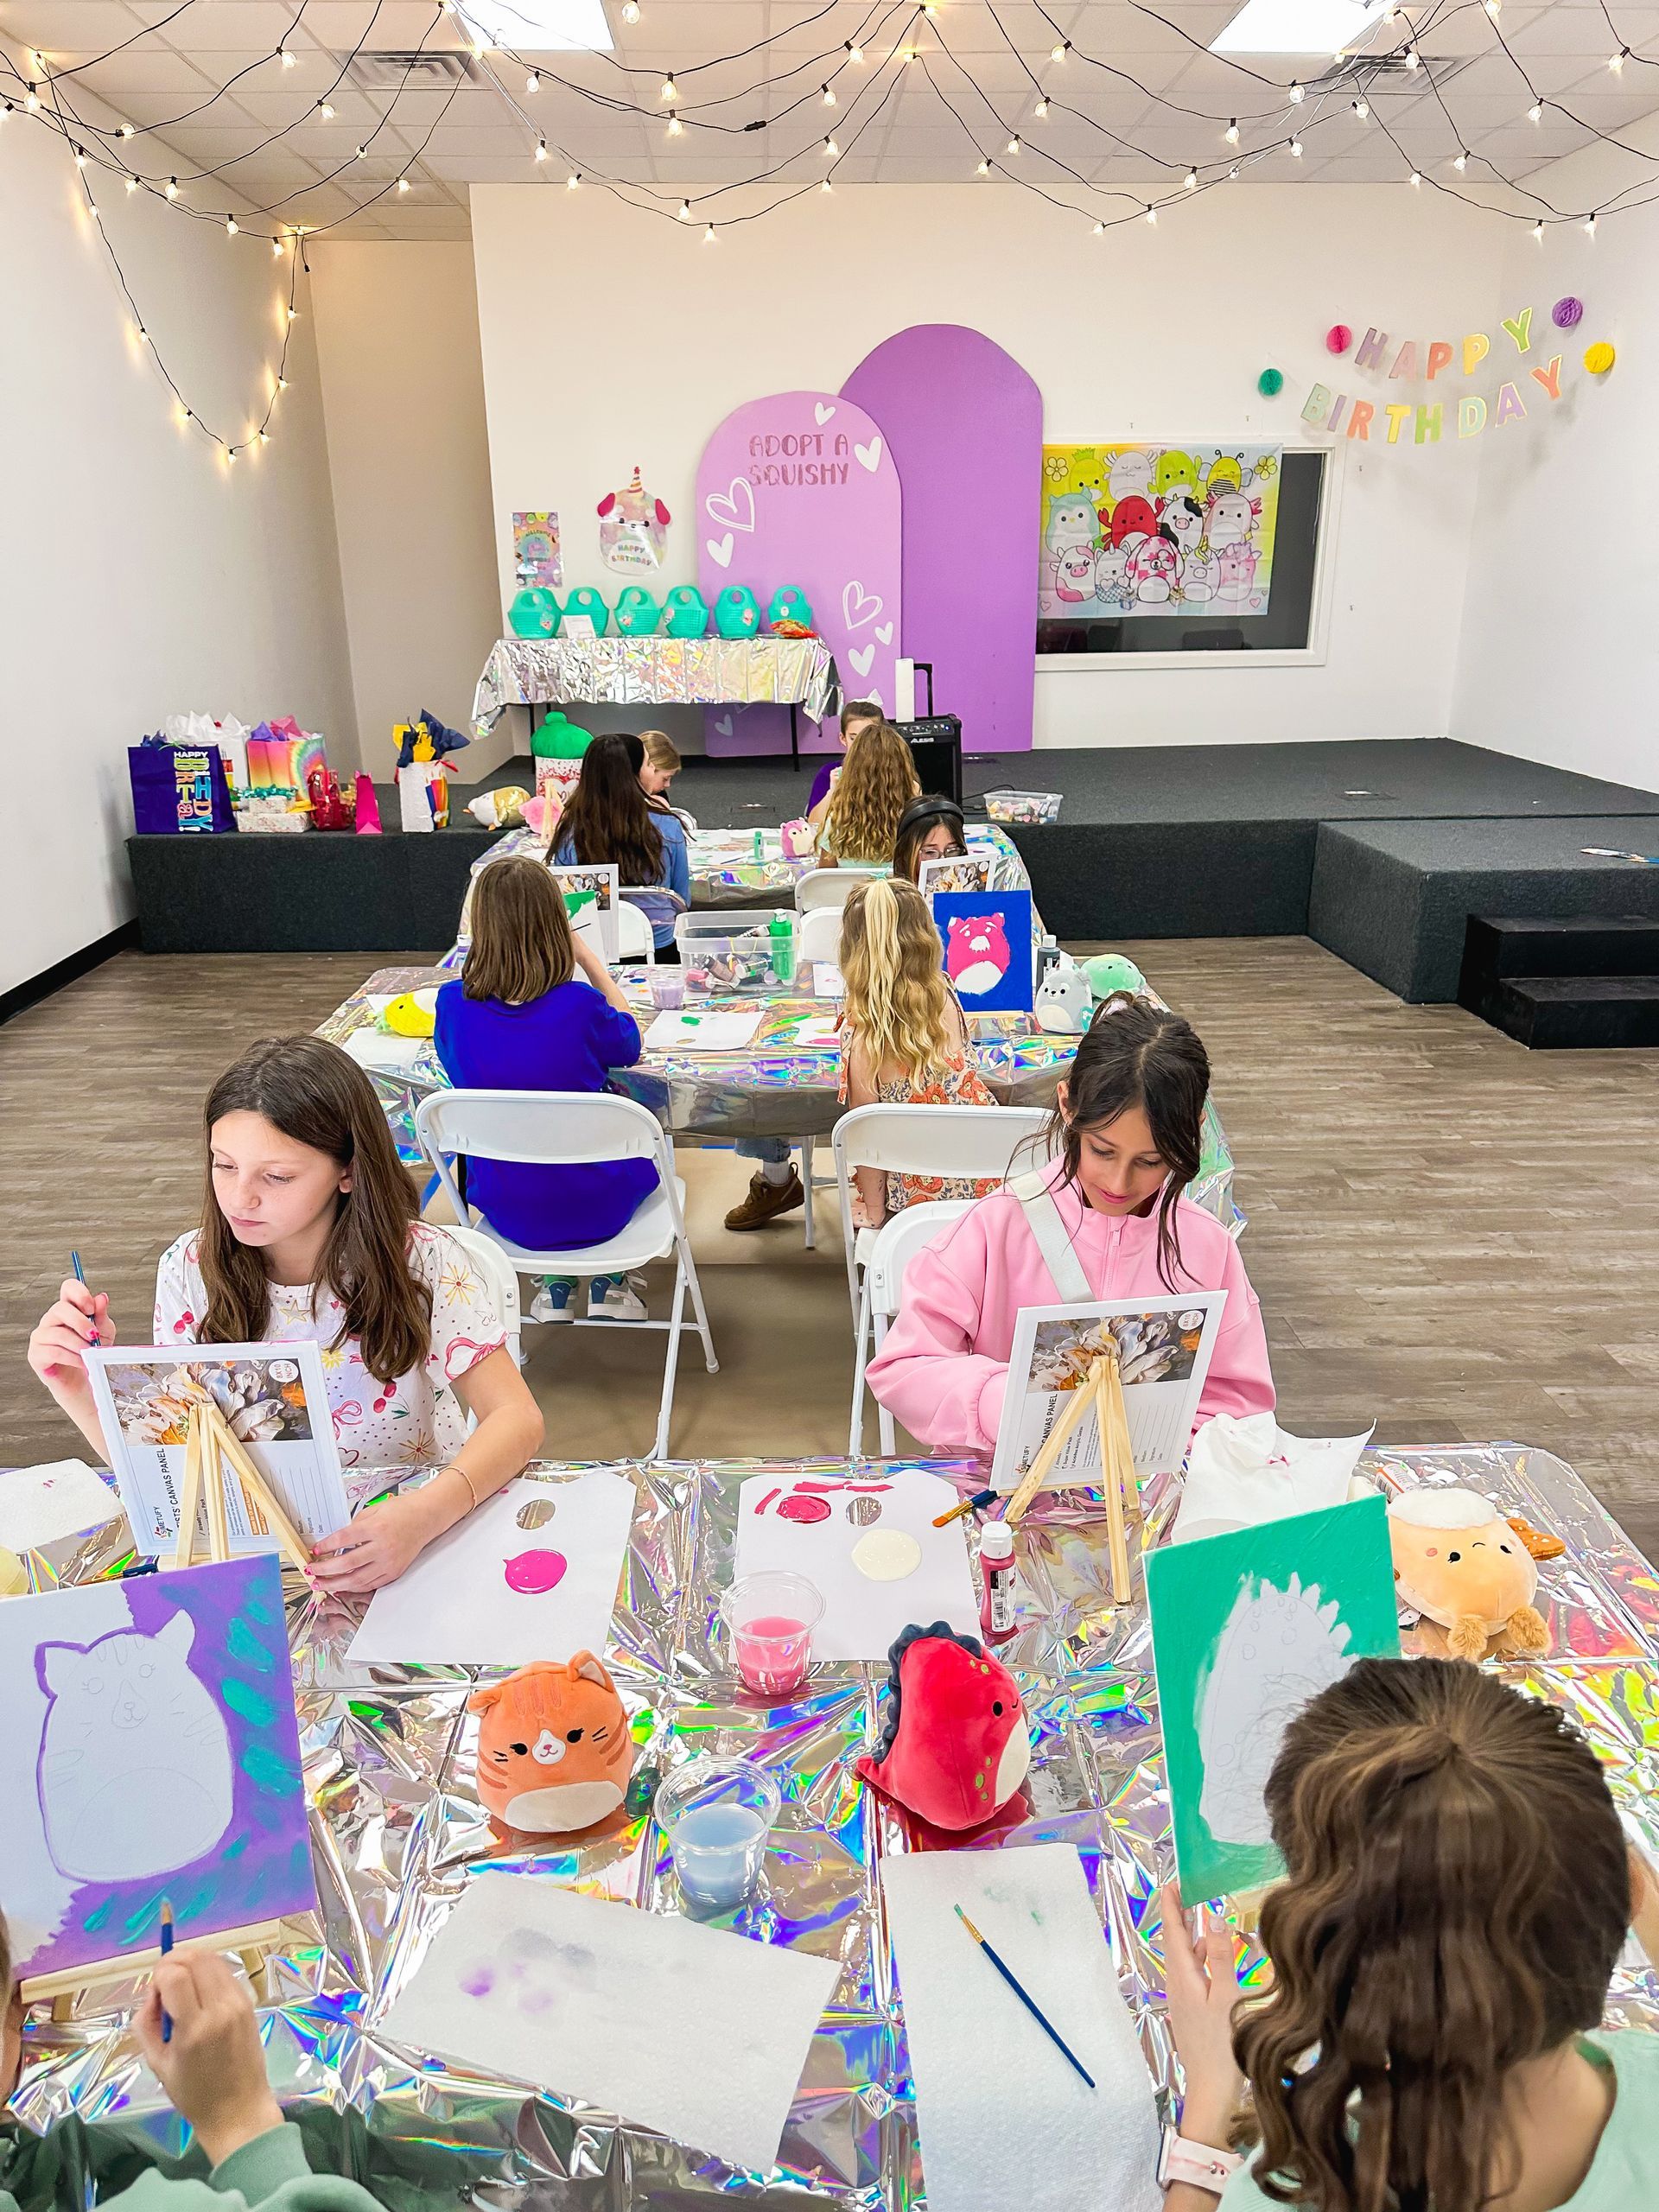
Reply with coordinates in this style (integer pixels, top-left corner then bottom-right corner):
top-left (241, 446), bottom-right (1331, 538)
top-left (471, 183), bottom-right (1500, 746)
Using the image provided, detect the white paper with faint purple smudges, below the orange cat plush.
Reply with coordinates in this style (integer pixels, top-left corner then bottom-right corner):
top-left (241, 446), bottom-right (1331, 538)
top-left (380, 1872), bottom-right (841, 2174)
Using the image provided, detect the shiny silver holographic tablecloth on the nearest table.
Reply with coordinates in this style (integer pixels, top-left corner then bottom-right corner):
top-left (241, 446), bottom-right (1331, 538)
top-left (16, 1445), bottom-right (1659, 2212)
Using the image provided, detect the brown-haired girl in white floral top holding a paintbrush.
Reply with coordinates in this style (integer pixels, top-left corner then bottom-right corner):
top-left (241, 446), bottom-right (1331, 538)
top-left (29, 1038), bottom-right (542, 1592)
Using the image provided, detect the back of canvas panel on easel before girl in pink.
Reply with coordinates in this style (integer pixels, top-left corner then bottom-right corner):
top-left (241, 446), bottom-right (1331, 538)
top-left (991, 1289), bottom-right (1228, 1491)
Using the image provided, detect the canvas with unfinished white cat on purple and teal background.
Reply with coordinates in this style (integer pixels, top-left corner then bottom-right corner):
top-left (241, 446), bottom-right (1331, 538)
top-left (0, 1553), bottom-right (316, 1980)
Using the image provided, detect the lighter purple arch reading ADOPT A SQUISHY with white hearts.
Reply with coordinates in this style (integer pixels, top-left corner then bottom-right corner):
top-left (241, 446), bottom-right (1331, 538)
top-left (696, 391), bottom-right (911, 752)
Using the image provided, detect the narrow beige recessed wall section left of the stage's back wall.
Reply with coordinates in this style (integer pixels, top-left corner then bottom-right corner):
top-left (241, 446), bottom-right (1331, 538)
top-left (309, 238), bottom-right (506, 777)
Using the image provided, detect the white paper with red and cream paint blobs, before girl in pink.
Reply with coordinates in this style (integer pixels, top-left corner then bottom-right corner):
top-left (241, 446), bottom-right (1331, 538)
top-left (734, 1466), bottom-right (980, 1659)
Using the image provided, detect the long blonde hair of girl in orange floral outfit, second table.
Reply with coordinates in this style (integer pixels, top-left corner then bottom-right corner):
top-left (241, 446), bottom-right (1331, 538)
top-left (841, 876), bottom-right (957, 1084)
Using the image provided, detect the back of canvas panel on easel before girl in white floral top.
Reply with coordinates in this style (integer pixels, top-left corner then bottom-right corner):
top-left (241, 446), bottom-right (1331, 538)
top-left (86, 1343), bottom-right (352, 1553)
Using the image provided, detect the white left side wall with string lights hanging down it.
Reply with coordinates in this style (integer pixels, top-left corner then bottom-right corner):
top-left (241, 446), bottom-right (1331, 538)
top-left (0, 54), bottom-right (356, 991)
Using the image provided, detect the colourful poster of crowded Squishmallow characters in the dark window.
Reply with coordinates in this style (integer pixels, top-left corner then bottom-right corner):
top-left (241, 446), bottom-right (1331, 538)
top-left (1038, 445), bottom-right (1283, 621)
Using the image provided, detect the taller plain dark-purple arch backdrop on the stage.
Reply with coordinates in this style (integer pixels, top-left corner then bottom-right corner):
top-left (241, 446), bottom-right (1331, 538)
top-left (841, 323), bottom-right (1042, 752)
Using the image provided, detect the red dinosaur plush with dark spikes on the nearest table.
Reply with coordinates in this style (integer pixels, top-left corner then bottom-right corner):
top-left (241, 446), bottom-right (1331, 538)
top-left (856, 1621), bottom-right (1031, 1834)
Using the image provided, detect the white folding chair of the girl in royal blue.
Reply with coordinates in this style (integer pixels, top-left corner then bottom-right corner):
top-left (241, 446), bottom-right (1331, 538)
top-left (416, 1090), bottom-right (719, 1460)
